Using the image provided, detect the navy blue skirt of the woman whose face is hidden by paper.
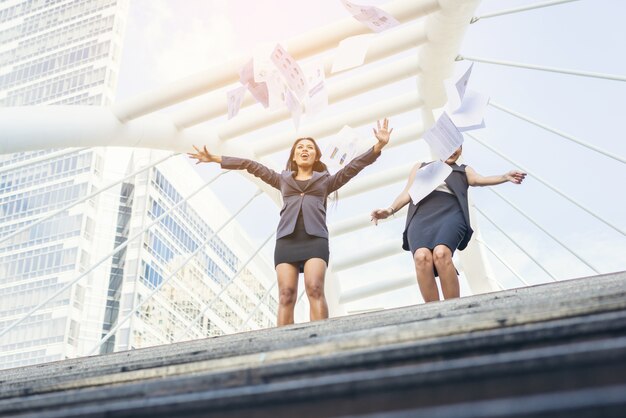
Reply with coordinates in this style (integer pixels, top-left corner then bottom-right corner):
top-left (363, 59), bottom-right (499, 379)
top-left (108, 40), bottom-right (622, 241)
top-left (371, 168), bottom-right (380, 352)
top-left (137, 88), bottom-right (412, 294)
top-left (407, 191), bottom-right (467, 254)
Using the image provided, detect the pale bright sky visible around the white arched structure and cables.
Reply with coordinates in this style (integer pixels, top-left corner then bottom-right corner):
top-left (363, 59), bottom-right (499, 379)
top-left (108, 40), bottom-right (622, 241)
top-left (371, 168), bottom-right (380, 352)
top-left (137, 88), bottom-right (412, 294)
top-left (117, 0), bottom-right (626, 311)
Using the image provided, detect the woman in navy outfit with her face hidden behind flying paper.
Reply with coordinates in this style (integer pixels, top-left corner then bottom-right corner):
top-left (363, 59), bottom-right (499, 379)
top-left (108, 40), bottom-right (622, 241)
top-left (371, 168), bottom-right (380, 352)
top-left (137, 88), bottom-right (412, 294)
top-left (371, 147), bottom-right (526, 302)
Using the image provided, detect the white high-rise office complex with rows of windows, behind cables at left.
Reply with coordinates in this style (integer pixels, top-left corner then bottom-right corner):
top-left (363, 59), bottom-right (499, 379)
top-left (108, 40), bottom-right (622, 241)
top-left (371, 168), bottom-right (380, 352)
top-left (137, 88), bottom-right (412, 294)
top-left (0, 0), bottom-right (276, 368)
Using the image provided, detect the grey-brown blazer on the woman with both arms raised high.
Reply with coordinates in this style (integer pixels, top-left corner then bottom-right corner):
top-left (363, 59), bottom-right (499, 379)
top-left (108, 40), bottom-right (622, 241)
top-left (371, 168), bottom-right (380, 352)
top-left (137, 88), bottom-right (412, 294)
top-left (222, 147), bottom-right (380, 239)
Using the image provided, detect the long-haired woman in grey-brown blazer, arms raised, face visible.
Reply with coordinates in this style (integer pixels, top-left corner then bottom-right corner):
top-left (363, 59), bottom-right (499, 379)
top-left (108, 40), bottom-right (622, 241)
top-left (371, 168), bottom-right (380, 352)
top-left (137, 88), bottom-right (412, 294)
top-left (189, 119), bottom-right (393, 326)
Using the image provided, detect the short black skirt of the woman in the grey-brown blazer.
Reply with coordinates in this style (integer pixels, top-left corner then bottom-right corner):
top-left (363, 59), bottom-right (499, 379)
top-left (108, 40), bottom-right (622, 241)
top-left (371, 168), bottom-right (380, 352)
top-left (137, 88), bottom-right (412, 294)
top-left (274, 211), bottom-right (330, 273)
